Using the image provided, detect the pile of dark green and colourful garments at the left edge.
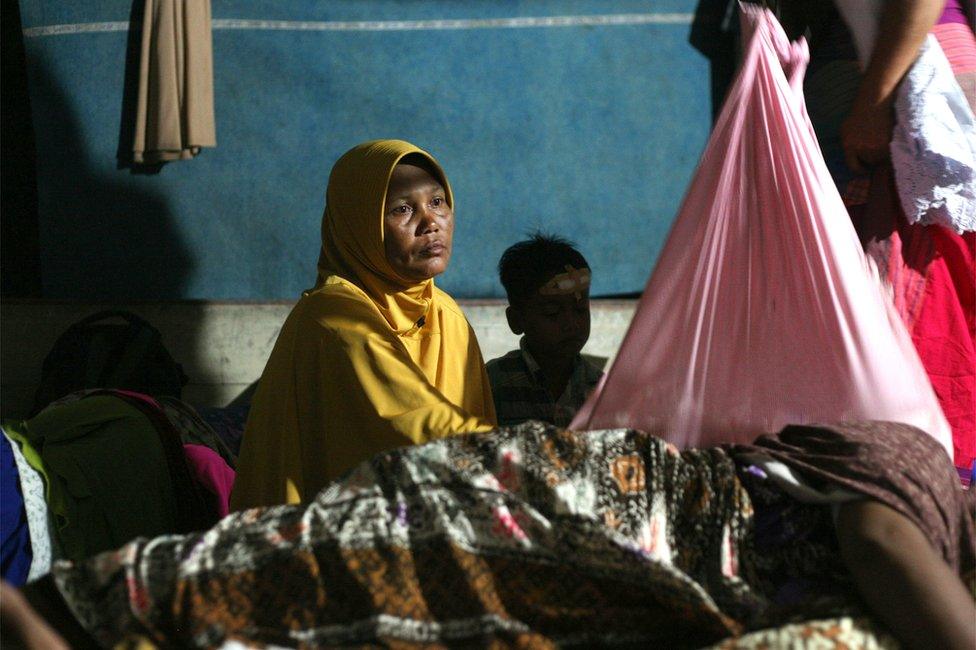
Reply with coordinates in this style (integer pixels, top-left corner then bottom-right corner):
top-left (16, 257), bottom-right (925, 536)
top-left (0, 390), bottom-right (234, 584)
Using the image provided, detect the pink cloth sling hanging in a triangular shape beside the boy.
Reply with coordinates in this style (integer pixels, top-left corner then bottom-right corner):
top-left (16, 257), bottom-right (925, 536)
top-left (571, 5), bottom-right (951, 455)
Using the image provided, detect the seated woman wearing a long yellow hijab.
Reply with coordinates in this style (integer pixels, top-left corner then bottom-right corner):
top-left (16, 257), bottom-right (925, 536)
top-left (231, 140), bottom-right (495, 510)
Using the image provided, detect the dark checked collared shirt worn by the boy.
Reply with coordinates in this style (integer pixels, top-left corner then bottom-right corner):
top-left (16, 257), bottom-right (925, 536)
top-left (487, 338), bottom-right (603, 427)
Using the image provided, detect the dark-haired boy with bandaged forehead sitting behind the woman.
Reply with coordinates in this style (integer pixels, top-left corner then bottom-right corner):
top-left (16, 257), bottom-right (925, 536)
top-left (488, 233), bottom-right (603, 427)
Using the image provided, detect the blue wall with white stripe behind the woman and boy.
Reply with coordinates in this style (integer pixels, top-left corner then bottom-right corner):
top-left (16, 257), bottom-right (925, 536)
top-left (21, 0), bottom-right (710, 300)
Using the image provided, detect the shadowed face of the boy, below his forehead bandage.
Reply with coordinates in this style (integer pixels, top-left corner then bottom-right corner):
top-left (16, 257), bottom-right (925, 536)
top-left (505, 287), bottom-right (590, 360)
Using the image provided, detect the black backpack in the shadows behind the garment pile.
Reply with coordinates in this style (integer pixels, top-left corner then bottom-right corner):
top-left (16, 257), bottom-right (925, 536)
top-left (31, 310), bottom-right (187, 415)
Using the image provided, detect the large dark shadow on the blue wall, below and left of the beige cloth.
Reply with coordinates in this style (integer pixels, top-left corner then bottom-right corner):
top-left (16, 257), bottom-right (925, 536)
top-left (30, 57), bottom-right (195, 301)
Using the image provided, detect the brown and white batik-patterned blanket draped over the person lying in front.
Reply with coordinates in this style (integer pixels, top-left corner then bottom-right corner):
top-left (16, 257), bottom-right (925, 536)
top-left (45, 423), bottom-right (892, 648)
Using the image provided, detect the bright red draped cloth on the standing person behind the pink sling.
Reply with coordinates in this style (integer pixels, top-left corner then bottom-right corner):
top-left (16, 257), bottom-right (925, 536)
top-left (850, 168), bottom-right (976, 469)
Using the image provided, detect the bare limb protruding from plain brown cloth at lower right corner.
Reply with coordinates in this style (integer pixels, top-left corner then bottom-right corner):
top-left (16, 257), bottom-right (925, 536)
top-left (837, 500), bottom-right (976, 650)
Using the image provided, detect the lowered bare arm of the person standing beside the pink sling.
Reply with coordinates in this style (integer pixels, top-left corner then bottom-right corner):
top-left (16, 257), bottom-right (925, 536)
top-left (840, 0), bottom-right (945, 174)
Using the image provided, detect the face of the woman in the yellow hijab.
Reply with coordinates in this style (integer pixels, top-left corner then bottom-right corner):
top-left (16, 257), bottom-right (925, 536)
top-left (383, 163), bottom-right (454, 282)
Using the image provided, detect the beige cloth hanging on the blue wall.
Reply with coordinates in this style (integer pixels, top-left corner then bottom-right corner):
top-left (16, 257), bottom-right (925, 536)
top-left (132, 0), bottom-right (217, 164)
